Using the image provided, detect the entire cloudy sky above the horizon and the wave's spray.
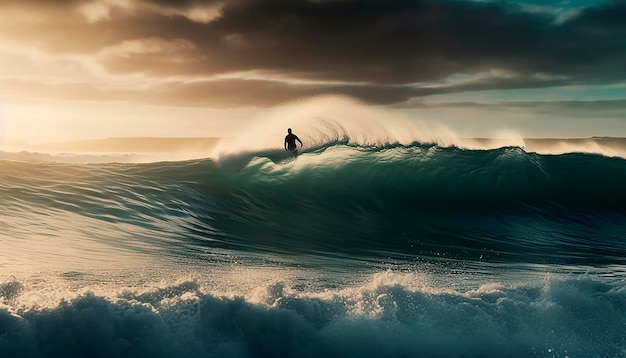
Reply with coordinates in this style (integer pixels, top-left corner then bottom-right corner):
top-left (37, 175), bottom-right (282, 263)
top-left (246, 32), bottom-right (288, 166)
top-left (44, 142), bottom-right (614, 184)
top-left (0, 0), bottom-right (626, 143)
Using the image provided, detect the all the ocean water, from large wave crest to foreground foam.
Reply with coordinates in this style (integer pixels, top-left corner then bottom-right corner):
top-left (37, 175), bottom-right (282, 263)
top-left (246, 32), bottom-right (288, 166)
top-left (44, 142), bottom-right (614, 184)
top-left (0, 141), bottom-right (626, 358)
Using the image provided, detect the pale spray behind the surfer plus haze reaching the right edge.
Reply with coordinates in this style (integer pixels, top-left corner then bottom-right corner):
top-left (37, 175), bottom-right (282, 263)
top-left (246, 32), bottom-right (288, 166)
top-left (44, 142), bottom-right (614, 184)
top-left (210, 96), bottom-right (626, 158)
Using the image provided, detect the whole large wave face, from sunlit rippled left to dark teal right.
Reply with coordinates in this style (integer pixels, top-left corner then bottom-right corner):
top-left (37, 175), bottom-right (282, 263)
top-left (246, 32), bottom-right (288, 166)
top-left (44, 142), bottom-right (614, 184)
top-left (0, 143), bottom-right (626, 264)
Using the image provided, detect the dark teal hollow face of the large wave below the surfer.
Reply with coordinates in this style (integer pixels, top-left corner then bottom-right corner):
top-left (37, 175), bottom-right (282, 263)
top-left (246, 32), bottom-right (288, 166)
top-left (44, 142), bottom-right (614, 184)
top-left (200, 145), bottom-right (626, 262)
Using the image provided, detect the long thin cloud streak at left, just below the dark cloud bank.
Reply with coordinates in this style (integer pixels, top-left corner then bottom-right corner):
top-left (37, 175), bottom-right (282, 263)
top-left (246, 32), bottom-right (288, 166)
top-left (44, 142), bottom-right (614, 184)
top-left (0, 79), bottom-right (428, 108)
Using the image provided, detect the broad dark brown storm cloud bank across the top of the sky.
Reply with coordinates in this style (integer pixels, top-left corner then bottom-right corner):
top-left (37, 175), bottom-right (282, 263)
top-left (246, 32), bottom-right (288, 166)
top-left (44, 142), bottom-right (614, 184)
top-left (0, 0), bottom-right (626, 103)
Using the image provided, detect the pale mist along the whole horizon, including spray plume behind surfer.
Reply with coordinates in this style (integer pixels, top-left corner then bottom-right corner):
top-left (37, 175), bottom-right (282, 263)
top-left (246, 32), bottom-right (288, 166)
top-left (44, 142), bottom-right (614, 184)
top-left (0, 95), bottom-right (626, 163)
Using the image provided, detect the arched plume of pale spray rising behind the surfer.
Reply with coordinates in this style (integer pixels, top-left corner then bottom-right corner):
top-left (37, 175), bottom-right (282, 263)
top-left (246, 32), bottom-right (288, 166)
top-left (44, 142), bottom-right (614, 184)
top-left (214, 96), bottom-right (482, 156)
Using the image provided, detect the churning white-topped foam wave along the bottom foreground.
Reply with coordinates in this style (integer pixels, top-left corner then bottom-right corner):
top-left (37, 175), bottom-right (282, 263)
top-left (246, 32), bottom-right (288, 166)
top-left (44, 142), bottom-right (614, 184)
top-left (0, 272), bottom-right (626, 357)
